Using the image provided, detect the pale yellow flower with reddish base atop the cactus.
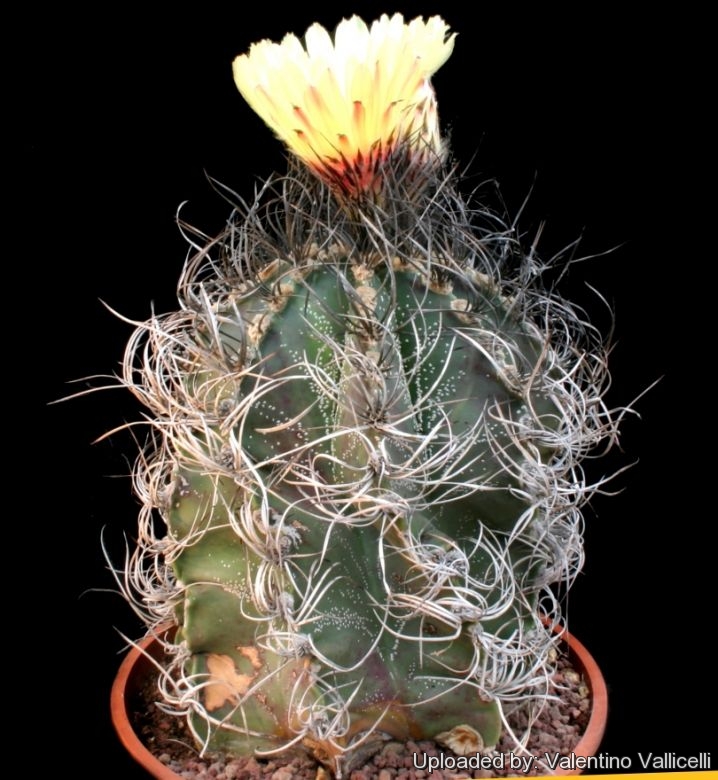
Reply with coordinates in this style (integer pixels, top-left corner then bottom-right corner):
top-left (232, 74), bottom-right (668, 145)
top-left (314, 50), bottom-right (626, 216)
top-left (233, 14), bottom-right (455, 195)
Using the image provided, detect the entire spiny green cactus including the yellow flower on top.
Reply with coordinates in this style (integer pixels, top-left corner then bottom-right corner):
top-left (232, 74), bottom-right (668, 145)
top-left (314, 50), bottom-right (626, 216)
top-left (109, 14), bottom-right (624, 777)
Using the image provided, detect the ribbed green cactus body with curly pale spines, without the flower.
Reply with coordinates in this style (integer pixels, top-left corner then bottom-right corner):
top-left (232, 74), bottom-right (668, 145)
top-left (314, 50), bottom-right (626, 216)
top-left (116, 168), bottom-right (600, 774)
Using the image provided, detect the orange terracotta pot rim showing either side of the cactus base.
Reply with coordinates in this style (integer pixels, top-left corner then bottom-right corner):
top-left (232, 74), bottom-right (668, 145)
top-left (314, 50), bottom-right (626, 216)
top-left (111, 629), bottom-right (608, 780)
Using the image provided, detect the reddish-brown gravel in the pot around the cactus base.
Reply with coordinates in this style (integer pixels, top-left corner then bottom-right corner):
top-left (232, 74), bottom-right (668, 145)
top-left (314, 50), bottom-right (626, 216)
top-left (133, 658), bottom-right (590, 780)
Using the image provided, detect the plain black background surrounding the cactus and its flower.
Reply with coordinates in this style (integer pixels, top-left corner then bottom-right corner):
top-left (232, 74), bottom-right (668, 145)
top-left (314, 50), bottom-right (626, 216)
top-left (23, 0), bottom-right (718, 778)
